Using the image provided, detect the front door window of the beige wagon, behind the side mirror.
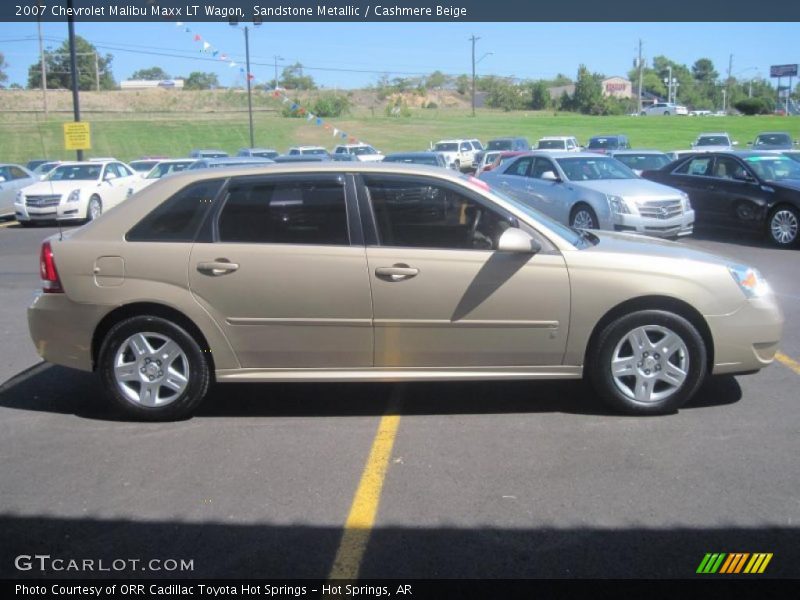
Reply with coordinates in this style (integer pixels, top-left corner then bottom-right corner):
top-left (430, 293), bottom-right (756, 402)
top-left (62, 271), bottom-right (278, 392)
top-left (364, 176), bottom-right (513, 250)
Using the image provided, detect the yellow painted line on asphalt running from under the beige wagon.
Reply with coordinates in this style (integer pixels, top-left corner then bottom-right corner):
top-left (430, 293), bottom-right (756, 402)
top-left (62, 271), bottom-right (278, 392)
top-left (328, 384), bottom-right (402, 580)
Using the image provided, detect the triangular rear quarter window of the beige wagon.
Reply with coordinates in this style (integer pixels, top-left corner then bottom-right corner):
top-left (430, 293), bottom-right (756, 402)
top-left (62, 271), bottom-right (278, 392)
top-left (125, 179), bottom-right (222, 242)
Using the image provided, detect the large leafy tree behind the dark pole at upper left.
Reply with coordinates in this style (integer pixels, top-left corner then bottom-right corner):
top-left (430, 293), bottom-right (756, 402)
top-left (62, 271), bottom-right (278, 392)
top-left (28, 35), bottom-right (117, 90)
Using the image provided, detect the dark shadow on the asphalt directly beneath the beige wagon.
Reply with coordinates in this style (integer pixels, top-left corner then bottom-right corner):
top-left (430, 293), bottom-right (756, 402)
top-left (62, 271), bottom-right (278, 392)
top-left (0, 363), bottom-right (742, 420)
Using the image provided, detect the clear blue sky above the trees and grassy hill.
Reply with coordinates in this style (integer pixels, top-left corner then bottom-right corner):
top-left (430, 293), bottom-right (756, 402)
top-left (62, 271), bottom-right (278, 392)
top-left (0, 22), bottom-right (800, 88)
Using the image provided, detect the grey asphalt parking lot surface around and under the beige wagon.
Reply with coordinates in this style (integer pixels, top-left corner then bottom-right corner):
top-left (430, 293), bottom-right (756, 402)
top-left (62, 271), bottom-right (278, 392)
top-left (0, 222), bottom-right (800, 578)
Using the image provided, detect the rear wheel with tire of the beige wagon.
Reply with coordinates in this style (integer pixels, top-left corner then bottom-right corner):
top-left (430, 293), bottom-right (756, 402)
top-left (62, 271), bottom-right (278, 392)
top-left (97, 315), bottom-right (211, 421)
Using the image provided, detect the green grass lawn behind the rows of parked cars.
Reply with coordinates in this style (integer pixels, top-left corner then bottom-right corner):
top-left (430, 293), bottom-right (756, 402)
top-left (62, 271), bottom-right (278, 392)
top-left (0, 110), bottom-right (800, 162)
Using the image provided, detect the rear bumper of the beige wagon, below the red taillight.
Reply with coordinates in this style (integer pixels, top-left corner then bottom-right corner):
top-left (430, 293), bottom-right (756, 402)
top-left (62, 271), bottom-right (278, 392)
top-left (28, 292), bottom-right (113, 371)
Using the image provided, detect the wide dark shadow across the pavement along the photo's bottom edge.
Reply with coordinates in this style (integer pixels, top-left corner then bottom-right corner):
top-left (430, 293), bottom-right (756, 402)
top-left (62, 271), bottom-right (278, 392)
top-left (0, 502), bottom-right (800, 580)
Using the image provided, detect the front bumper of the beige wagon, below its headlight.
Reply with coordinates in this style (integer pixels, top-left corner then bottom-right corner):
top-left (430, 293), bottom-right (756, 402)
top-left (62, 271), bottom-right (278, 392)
top-left (705, 294), bottom-right (784, 375)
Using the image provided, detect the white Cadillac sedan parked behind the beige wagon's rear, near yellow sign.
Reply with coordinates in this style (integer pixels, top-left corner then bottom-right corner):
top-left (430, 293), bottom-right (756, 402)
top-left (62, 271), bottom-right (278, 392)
top-left (14, 161), bottom-right (139, 225)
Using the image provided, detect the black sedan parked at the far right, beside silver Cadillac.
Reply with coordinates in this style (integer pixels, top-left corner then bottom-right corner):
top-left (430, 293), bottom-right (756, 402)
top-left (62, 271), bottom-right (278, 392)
top-left (642, 151), bottom-right (800, 247)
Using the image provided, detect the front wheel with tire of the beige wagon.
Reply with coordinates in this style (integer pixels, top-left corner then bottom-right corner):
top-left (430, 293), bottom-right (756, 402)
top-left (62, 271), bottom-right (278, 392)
top-left (586, 310), bottom-right (707, 415)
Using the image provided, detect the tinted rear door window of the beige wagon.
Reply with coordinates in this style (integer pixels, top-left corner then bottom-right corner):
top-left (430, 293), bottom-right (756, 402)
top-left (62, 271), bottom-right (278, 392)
top-left (219, 175), bottom-right (350, 245)
